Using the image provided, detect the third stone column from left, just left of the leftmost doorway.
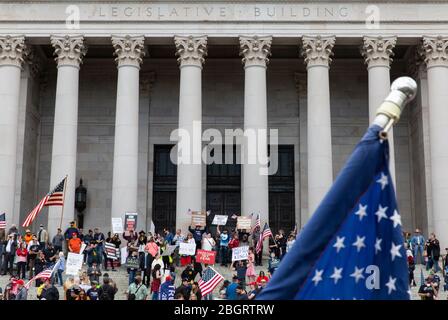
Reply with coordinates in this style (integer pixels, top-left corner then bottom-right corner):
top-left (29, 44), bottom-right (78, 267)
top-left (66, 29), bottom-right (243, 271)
top-left (109, 36), bottom-right (145, 226)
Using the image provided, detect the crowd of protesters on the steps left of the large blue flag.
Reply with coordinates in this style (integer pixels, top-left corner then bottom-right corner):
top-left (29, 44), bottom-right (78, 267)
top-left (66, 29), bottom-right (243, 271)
top-left (0, 221), bottom-right (296, 300)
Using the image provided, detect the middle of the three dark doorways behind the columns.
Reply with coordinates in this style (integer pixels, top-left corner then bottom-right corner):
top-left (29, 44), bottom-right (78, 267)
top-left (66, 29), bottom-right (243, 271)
top-left (206, 146), bottom-right (241, 232)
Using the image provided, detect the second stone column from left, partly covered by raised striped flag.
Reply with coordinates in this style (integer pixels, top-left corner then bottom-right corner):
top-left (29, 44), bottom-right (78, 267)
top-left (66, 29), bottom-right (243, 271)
top-left (48, 35), bottom-right (86, 235)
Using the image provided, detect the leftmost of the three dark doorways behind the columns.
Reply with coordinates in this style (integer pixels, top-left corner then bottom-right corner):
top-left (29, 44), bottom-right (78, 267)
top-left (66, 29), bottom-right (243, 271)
top-left (152, 145), bottom-right (177, 232)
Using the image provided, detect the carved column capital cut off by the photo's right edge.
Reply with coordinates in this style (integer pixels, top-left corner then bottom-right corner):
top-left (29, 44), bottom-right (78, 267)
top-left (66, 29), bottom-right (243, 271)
top-left (421, 35), bottom-right (448, 68)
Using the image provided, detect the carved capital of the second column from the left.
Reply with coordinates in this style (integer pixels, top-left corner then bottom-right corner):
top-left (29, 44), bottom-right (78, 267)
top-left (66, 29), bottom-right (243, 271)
top-left (51, 35), bottom-right (87, 68)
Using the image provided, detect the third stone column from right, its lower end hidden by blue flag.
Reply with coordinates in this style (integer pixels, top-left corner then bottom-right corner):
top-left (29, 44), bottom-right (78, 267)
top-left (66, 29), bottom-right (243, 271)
top-left (302, 36), bottom-right (336, 216)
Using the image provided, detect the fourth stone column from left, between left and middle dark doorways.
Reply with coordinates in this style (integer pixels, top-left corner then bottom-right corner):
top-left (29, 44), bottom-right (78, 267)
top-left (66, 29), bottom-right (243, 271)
top-left (174, 36), bottom-right (207, 231)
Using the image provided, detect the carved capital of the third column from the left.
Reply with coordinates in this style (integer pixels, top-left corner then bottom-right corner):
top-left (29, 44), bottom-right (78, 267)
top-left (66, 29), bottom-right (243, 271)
top-left (112, 35), bottom-right (145, 68)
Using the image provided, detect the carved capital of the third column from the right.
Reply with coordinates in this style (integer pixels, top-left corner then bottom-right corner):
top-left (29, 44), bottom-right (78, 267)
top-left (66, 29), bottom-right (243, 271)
top-left (302, 36), bottom-right (336, 68)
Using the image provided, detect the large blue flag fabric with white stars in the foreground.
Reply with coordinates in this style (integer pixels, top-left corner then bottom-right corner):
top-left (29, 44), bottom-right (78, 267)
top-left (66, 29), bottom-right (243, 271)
top-left (257, 125), bottom-right (410, 300)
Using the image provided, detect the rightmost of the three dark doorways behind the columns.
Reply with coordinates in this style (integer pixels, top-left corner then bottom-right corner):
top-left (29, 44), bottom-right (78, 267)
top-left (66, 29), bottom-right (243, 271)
top-left (269, 145), bottom-right (295, 232)
